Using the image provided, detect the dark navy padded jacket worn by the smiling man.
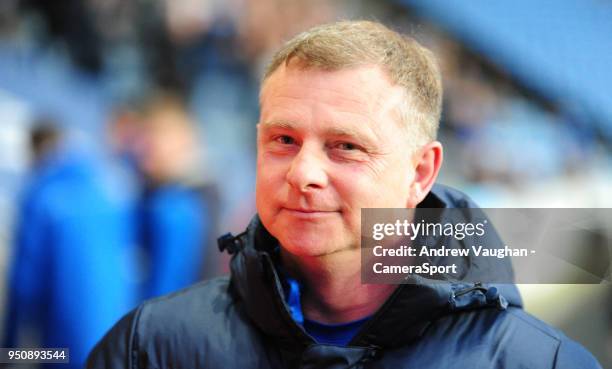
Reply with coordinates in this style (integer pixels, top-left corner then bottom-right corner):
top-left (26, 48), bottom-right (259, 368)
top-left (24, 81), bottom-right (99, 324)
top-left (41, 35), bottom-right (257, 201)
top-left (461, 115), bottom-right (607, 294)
top-left (87, 186), bottom-right (599, 369)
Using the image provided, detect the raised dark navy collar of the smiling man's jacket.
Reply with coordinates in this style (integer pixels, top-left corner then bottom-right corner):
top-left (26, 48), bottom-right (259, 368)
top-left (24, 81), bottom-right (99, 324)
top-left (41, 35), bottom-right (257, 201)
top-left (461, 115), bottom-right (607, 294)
top-left (231, 185), bottom-right (522, 347)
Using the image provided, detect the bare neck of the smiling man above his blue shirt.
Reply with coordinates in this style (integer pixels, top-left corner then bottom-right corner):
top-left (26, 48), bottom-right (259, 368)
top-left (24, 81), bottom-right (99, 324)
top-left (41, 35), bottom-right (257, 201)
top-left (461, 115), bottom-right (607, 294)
top-left (281, 249), bottom-right (396, 324)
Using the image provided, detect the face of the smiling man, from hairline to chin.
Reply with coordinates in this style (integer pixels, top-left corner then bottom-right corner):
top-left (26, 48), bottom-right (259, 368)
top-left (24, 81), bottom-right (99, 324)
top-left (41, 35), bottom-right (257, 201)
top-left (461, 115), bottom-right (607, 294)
top-left (256, 63), bottom-right (414, 256)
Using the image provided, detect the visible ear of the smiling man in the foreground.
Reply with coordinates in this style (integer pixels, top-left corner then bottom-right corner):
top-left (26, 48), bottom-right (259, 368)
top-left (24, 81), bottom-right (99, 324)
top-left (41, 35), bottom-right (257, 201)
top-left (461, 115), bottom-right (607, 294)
top-left (407, 141), bottom-right (443, 208)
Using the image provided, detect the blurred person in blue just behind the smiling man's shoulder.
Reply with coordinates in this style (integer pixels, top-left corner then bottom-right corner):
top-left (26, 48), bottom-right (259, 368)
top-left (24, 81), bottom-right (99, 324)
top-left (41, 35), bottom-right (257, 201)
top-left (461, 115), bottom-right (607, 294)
top-left (136, 93), bottom-right (216, 298)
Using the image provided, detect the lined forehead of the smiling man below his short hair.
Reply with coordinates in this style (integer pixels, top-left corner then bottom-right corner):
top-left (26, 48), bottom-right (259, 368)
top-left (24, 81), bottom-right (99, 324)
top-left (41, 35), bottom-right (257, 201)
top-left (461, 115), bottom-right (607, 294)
top-left (260, 63), bottom-right (404, 126)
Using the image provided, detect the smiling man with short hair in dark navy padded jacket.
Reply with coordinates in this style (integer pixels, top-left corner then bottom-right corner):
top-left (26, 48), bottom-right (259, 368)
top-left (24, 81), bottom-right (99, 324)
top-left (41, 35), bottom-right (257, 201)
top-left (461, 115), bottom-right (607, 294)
top-left (88, 21), bottom-right (598, 368)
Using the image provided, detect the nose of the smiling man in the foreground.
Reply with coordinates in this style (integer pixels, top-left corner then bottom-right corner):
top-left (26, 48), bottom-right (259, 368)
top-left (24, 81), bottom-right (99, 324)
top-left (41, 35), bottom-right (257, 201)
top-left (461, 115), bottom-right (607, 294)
top-left (287, 144), bottom-right (328, 192)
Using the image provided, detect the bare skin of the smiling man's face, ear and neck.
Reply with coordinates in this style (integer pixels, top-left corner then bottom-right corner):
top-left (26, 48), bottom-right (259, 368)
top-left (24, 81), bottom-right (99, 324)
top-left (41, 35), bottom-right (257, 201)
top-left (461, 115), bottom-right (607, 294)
top-left (257, 49), bottom-right (442, 324)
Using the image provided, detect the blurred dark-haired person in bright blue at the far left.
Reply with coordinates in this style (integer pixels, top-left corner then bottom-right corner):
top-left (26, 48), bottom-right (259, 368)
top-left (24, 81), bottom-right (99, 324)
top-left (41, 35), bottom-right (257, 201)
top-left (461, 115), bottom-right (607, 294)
top-left (2, 119), bottom-right (137, 368)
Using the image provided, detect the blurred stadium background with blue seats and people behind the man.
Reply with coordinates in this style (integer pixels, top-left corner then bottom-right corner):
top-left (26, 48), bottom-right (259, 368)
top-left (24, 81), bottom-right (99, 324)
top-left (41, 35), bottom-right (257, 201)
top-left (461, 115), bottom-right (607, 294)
top-left (0, 0), bottom-right (612, 368)
